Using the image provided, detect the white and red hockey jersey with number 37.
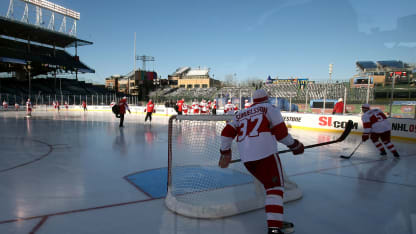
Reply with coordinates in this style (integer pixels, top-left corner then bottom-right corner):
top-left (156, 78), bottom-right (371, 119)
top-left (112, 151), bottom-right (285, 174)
top-left (221, 103), bottom-right (294, 162)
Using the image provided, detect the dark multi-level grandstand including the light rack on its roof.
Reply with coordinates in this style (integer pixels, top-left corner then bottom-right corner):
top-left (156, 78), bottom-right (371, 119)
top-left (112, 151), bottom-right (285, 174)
top-left (0, 0), bottom-right (101, 102)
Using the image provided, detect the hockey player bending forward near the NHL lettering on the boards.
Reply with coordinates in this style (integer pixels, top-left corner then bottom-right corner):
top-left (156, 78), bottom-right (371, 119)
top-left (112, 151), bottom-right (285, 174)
top-left (361, 104), bottom-right (400, 158)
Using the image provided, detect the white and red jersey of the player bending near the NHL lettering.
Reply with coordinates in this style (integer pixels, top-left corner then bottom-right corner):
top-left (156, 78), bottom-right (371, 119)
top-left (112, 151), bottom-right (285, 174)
top-left (361, 108), bottom-right (391, 133)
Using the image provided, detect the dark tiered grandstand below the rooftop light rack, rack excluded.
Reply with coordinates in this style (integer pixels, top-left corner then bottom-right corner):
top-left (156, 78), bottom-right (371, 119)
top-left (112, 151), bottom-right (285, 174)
top-left (0, 16), bottom-right (121, 104)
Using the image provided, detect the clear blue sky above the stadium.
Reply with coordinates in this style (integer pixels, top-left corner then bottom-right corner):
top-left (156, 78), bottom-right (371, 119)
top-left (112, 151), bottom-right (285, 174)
top-left (0, 0), bottom-right (416, 83)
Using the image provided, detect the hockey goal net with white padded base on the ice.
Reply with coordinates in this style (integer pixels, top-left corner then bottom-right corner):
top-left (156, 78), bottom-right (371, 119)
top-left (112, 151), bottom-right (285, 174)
top-left (165, 115), bottom-right (302, 218)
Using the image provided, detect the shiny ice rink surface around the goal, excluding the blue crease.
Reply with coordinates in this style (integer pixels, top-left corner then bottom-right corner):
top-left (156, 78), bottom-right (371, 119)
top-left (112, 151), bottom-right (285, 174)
top-left (0, 111), bottom-right (416, 234)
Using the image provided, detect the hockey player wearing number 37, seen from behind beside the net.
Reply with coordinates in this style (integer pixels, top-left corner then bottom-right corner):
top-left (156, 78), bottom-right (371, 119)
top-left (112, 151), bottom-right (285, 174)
top-left (219, 89), bottom-right (304, 234)
